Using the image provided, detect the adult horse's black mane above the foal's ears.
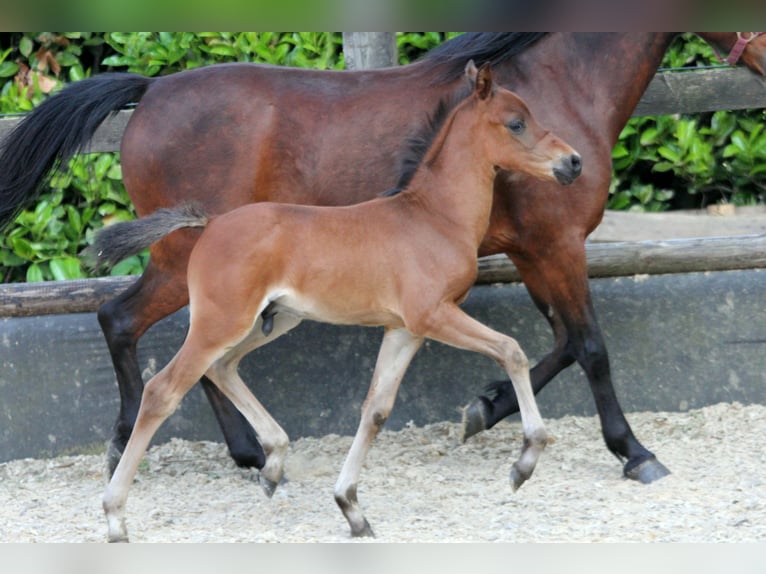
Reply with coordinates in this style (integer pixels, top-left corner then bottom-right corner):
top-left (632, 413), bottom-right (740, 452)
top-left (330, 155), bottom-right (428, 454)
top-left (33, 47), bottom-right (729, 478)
top-left (419, 32), bottom-right (547, 82)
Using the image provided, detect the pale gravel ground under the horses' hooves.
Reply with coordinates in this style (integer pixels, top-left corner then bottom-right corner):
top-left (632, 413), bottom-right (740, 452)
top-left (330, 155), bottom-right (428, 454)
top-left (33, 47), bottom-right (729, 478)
top-left (0, 403), bottom-right (766, 542)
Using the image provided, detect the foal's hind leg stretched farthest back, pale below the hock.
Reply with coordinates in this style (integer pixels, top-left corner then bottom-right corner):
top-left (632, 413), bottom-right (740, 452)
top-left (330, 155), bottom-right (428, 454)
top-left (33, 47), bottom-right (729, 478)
top-left (103, 343), bottom-right (218, 542)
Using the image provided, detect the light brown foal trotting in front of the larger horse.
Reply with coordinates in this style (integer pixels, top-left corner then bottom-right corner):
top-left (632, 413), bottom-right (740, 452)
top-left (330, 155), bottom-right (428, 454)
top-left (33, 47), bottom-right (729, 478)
top-left (90, 62), bottom-right (581, 542)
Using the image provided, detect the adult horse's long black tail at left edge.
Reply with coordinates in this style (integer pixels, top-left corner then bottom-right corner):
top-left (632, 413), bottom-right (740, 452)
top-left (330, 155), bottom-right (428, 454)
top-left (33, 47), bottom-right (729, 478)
top-left (0, 73), bottom-right (153, 230)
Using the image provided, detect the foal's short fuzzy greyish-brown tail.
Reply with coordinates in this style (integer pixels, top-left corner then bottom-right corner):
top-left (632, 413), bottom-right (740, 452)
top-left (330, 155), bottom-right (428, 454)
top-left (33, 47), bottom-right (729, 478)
top-left (80, 203), bottom-right (209, 269)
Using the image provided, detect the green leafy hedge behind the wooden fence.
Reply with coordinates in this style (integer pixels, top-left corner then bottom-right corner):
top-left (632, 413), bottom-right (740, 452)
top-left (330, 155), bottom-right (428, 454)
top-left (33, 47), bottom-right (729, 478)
top-left (0, 32), bottom-right (766, 282)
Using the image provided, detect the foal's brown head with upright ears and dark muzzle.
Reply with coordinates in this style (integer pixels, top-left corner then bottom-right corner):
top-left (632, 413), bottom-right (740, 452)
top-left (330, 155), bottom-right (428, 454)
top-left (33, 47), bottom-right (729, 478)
top-left (466, 61), bottom-right (582, 185)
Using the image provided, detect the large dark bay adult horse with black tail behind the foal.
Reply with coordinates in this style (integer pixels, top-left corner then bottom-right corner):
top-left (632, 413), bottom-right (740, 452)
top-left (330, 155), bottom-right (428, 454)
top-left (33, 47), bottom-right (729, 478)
top-left (0, 32), bottom-right (766, 482)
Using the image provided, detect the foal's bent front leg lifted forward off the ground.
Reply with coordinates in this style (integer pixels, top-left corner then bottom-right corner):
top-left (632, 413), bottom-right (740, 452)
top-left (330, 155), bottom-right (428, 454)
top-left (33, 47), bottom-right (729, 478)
top-left (425, 304), bottom-right (548, 490)
